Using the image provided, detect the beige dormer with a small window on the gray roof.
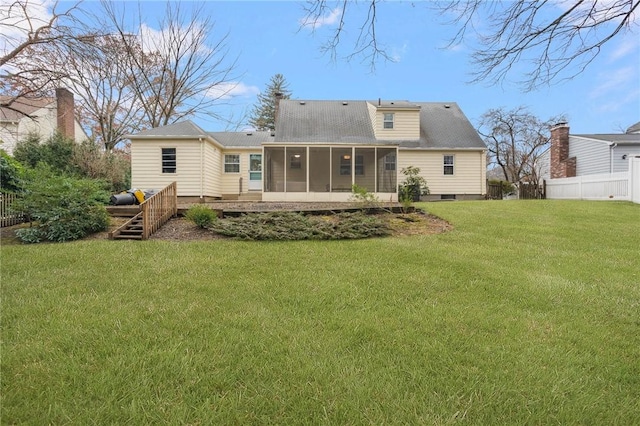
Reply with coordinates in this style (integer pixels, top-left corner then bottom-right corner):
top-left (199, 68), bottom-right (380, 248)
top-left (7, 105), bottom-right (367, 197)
top-left (368, 100), bottom-right (420, 140)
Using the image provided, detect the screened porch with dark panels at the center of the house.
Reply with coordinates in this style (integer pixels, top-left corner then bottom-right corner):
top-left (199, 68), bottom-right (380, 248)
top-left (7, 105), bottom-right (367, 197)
top-left (262, 144), bottom-right (398, 202)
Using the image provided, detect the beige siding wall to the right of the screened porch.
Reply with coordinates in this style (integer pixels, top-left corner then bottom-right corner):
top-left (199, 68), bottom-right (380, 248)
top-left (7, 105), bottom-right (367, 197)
top-left (398, 150), bottom-right (486, 195)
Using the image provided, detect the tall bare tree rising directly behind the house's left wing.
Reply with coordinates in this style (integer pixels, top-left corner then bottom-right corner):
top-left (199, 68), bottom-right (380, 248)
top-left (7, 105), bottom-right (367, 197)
top-left (102, 1), bottom-right (236, 127)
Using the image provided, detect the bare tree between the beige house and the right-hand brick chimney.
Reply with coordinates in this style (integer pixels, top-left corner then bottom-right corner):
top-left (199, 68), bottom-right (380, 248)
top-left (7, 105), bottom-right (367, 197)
top-left (478, 106), bottom-right (561, 183)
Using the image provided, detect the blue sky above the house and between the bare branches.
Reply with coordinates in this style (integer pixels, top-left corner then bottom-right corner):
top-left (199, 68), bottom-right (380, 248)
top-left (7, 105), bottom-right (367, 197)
top-left (69, 1), bottom-right (640, 133)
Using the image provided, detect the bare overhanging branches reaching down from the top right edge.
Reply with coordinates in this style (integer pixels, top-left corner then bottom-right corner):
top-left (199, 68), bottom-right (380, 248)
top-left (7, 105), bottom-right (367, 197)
top-left (303, 0), bottom-right (640, 91)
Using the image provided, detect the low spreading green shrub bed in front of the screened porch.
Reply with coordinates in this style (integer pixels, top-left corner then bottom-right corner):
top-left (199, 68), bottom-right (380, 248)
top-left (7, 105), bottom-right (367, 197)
top-left (209, 212), bottom-right (390, 240)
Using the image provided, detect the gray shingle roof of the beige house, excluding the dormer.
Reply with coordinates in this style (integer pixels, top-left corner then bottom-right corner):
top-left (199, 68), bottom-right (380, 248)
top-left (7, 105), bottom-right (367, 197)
top-left (134, 99), bottom-right (486, 149)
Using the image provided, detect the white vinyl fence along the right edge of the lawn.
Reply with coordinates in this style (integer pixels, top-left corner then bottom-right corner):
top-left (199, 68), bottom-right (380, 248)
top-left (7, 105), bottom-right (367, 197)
top-left (546, 157), bottom-right (640, 203)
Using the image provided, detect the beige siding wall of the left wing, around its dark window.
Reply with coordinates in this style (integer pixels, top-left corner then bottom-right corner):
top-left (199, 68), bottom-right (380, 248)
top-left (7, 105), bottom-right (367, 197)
top-left (131, 139), bottom-right (217, 197)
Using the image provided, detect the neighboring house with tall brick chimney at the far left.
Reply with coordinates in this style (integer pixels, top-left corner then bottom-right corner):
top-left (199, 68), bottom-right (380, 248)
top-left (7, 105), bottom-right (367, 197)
top-left (0, 89), bottom-right (87, 154)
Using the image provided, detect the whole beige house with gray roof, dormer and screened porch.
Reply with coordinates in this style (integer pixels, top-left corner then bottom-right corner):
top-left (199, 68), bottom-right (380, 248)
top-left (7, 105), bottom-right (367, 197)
top-left (128, 100), bottom-right (486, 201)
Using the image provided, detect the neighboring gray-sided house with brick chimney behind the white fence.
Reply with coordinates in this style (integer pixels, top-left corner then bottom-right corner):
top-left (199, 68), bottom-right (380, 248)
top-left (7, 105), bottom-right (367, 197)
top-left (538, 123), bottom-right (640, 179)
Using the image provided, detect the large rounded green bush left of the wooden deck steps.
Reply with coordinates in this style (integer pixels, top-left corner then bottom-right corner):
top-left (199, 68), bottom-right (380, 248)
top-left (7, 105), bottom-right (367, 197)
top-left (15, 165), bottom-right (109, 243)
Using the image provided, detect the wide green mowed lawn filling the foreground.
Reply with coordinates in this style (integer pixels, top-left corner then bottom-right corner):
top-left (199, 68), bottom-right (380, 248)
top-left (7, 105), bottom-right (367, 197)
top-left (0, 200), bottom-right (640, 425)
